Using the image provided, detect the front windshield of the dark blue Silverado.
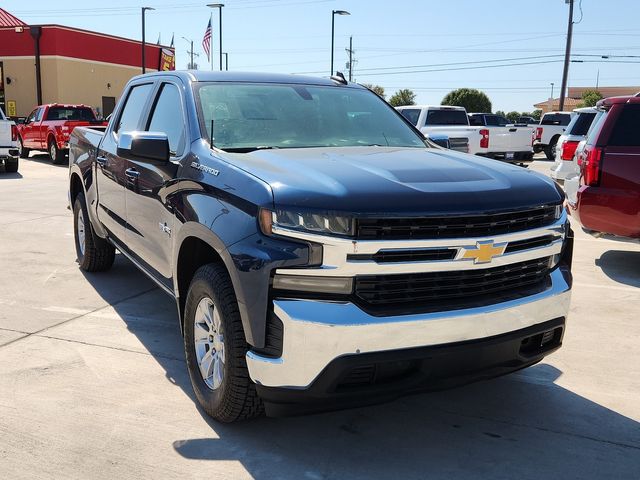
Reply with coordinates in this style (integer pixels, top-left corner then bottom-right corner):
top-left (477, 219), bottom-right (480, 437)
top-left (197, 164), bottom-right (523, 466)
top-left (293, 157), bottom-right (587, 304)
top-left (196, 83), bottom-right (426, 152)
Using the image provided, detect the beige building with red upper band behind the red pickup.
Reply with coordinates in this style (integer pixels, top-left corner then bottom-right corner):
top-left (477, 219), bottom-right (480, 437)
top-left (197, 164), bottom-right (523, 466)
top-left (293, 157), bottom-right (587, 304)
top-left (0, 9), bottom-right (175, 117)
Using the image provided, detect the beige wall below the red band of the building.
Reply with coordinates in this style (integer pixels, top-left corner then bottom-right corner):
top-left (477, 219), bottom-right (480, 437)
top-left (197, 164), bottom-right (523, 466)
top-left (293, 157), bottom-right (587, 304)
top-left (0, 56), bottom-right (152, 117)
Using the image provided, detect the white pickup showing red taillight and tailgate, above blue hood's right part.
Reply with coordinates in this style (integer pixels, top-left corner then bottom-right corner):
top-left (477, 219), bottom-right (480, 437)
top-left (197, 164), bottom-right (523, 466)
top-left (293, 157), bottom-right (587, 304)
top-left (469, 113), bottom-right (533, 163)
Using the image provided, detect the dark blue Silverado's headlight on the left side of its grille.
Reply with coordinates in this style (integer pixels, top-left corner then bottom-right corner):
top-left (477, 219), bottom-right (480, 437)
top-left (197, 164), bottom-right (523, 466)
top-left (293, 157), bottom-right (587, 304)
top-left (260, 209), bottom-right (354, 236)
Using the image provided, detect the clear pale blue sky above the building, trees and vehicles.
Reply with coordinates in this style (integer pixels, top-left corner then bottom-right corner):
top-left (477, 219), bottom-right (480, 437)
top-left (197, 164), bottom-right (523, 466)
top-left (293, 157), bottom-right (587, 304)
top-left (2, 0), bottom-right (640, 111)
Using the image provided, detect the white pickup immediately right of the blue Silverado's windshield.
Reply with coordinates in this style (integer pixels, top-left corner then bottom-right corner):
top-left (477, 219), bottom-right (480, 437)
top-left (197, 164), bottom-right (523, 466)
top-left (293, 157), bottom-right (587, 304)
top-left (396, 105), bottom-right (482, 153)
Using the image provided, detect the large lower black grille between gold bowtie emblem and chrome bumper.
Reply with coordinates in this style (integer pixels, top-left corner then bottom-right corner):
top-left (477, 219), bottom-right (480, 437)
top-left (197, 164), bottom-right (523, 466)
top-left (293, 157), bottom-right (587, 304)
top-left (355, 257), bottom-right (550, 313)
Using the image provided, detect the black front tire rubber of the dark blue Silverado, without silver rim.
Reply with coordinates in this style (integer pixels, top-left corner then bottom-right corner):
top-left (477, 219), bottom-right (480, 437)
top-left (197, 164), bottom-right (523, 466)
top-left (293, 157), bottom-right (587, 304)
top-left (184, 263), bottom-right (264, 423)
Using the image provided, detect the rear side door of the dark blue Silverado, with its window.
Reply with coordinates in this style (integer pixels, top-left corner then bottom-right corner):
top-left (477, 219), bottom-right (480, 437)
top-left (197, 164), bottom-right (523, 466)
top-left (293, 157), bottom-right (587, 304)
top-left (96, 83), bottom-right (153, 245)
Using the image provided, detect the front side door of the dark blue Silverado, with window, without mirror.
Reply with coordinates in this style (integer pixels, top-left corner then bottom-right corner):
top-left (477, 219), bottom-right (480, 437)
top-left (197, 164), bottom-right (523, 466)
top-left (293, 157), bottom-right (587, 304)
top-left (125, 82), bottom-right (188, 289)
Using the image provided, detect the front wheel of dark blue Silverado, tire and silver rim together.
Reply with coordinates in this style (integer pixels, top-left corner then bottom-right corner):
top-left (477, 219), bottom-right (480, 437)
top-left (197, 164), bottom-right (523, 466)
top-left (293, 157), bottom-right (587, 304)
top-left (184, 264), bottom-right (263, 423)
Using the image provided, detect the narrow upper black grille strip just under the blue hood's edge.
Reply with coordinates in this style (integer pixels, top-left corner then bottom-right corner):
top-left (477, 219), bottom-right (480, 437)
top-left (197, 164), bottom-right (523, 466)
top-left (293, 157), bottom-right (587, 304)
top-left (356, 205), bottom-right (556, 240)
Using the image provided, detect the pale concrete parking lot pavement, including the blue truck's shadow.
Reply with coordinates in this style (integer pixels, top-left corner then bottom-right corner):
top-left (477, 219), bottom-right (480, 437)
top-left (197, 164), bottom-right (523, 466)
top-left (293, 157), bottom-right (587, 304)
top-left (0, 155), bottom-right (640, 480)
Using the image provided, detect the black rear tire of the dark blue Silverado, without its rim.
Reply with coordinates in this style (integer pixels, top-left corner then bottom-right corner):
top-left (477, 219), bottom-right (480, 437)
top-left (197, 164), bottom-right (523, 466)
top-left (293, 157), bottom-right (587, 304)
top-left (73, 193), bottom-right (116, 272)
